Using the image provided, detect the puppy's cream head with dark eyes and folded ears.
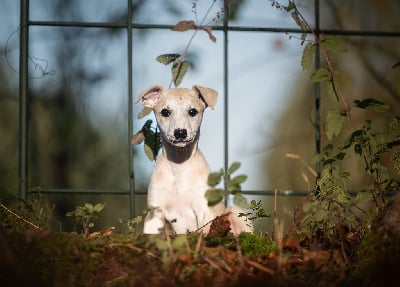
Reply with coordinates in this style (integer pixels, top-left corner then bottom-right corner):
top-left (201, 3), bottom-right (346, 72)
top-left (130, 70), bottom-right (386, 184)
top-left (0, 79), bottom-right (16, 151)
top-left (136, 86), bottom-right (218, 147)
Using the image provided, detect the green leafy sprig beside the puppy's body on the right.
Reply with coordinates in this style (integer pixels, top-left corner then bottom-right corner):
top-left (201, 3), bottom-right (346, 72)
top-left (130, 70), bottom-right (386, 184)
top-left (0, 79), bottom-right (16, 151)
top-left (206, 162), bottom-right (250, 208)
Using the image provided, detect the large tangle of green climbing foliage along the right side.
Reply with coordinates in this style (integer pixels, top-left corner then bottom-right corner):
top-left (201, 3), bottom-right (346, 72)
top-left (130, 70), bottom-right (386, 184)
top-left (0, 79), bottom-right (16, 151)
top-left (271, 0), bottom-right (400, 246)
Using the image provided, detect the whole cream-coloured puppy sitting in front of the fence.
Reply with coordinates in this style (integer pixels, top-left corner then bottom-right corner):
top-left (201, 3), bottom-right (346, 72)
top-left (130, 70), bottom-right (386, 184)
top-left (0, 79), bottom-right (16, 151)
top-left (137, 86), bottom-right (252, 234)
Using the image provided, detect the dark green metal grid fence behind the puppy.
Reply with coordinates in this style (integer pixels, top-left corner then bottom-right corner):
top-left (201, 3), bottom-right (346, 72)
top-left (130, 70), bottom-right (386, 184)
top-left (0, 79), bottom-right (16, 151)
top-left (19, 0), bottom-right (400, 217)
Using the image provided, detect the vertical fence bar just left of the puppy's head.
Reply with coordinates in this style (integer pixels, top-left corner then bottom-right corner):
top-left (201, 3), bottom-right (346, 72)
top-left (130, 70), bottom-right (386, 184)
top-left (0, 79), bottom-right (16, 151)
top-left (127, 0), bottom-right (135, 218)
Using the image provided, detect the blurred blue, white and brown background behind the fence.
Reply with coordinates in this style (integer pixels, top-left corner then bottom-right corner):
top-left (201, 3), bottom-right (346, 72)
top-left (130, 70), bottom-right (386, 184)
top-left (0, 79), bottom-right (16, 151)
top-left (0, 0), bottom-right (400, 232)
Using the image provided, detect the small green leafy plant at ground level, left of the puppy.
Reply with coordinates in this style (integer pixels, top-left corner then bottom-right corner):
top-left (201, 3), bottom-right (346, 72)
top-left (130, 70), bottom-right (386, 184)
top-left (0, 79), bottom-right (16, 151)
top-left (66, 203), bottom-right (106, 237)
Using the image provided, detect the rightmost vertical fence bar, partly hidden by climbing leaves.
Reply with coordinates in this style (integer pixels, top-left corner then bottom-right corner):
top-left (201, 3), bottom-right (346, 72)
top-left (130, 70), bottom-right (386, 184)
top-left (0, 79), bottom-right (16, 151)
top-left (314, 0), bottom-right (321, 178)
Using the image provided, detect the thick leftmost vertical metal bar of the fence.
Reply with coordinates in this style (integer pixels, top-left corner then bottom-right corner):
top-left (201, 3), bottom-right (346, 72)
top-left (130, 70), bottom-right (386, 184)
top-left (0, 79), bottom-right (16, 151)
top-left (18, 0), bottom-right (29, 199)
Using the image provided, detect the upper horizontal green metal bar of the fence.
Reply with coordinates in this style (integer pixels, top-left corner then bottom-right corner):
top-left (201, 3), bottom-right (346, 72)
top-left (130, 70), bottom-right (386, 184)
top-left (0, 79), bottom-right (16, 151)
top-left (29, 21), bottom-right (400, 37)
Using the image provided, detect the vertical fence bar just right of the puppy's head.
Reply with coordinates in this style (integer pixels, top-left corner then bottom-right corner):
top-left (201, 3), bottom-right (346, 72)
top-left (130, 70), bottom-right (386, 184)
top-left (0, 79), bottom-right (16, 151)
top-left (223, 5), bottom-right (229, 206)
